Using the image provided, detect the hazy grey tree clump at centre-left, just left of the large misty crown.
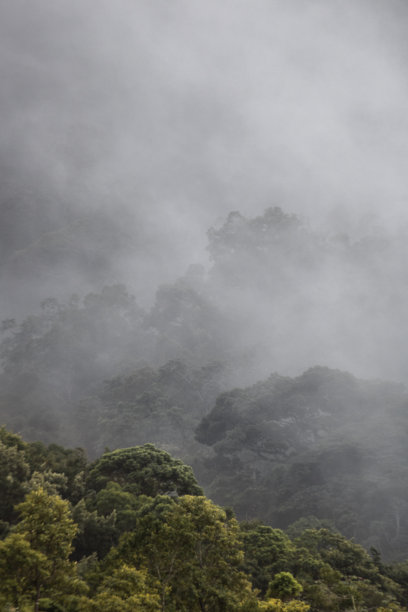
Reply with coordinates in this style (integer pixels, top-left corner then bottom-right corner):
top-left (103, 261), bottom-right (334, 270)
top-left (81, 361), bottom-right (225, 458)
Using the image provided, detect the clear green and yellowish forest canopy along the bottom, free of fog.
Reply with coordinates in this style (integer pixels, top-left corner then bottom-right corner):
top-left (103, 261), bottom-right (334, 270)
top-left (0, 428), bottom-right (408, 612)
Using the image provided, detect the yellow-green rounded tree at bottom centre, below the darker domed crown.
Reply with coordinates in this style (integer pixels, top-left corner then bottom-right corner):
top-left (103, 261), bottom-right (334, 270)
top-left (113, 495), bottom-right (250, 612)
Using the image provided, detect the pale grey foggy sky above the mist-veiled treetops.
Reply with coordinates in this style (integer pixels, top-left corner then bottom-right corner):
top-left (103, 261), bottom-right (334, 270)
top-left (0, 0), bottom-right (408, 310)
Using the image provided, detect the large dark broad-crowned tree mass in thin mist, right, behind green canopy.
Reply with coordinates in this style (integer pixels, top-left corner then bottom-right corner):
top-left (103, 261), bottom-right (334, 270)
top-left (196, 367), bottom-right (408, 556)
